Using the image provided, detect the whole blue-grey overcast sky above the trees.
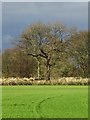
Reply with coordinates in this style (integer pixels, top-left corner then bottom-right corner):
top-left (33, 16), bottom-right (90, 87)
top-left (2, 2), bottom-right (88, 48)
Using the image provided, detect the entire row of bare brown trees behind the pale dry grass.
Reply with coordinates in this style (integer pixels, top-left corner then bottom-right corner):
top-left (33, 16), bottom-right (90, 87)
top-left (2, 23), bottom-right (89, 80)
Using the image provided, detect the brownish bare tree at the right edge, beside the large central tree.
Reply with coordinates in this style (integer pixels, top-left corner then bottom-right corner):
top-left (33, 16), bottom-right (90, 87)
top-left (69, 31), bottom-right (88, 77)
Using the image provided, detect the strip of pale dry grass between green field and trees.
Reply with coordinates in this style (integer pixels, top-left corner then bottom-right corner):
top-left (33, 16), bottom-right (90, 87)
top-left (0, 77), bottom-right (90, 85)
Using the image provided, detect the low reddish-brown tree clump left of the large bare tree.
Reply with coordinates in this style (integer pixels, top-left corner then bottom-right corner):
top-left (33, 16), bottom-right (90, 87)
top-left (2, 48), bottom-right (37, 77)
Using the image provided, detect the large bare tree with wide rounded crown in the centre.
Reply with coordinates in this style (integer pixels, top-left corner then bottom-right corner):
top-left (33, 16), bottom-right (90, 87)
top-left (20, 23), bottom-right (69, 80)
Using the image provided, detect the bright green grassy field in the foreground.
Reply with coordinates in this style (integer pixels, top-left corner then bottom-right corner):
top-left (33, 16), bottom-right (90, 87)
top-left (2, 86), bottom-right (88, 118)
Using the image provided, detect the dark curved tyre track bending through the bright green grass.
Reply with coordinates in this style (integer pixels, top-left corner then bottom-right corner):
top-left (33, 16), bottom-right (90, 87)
top-left (35, 95), bottom-right (63, 118)
